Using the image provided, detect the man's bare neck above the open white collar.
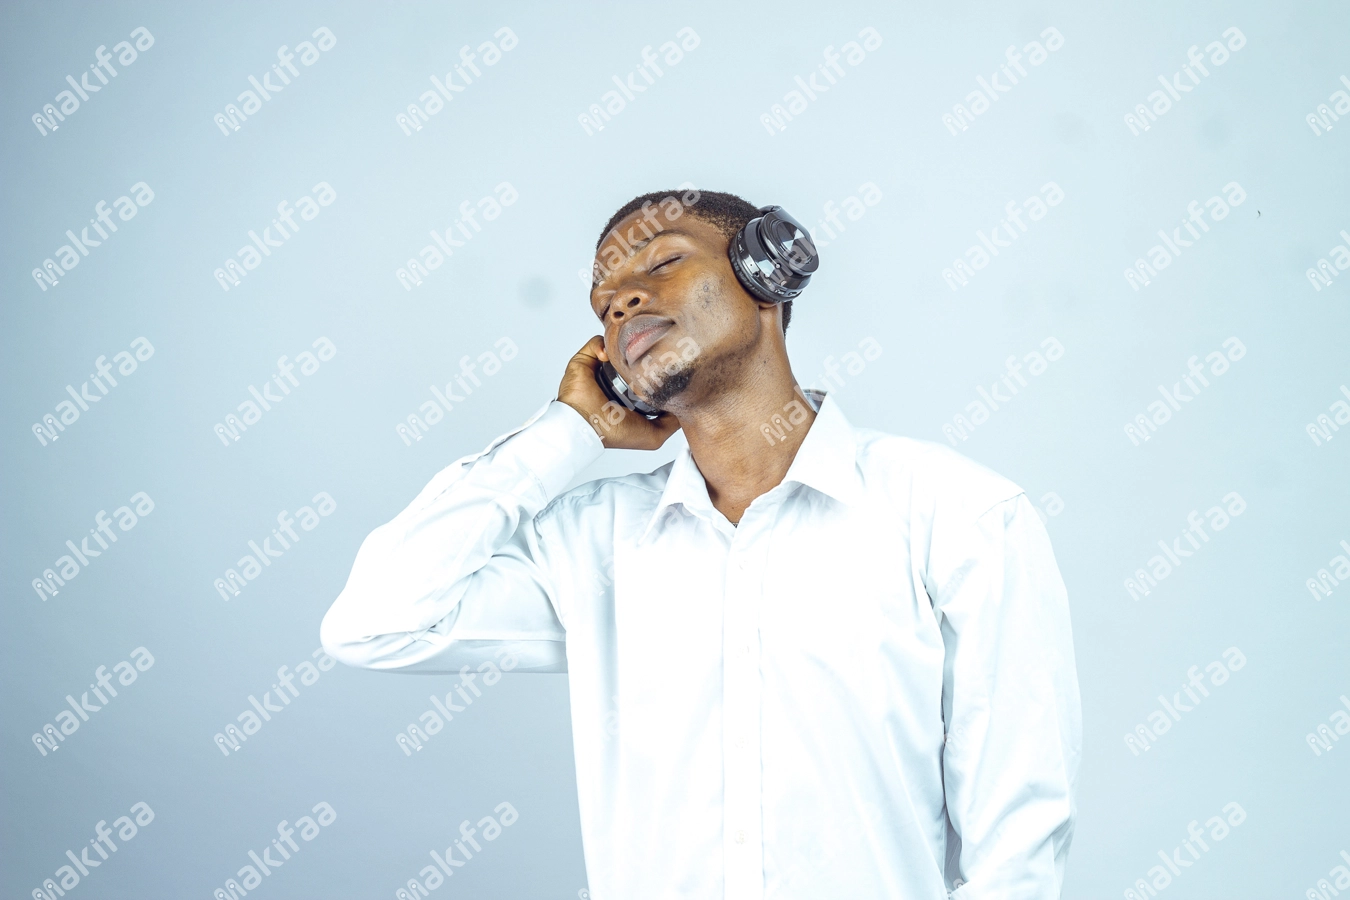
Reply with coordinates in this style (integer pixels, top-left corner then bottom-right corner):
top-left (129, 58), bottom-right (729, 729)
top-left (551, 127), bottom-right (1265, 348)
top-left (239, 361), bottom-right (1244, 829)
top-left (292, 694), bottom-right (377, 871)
top-left (672, 354), bottom-right (815, 524)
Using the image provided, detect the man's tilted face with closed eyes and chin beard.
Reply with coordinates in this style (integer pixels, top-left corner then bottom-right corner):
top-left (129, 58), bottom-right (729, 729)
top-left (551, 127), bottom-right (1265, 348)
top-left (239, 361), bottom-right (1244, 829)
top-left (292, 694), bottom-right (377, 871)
top-left (590, 210), bottom-right (778, 409)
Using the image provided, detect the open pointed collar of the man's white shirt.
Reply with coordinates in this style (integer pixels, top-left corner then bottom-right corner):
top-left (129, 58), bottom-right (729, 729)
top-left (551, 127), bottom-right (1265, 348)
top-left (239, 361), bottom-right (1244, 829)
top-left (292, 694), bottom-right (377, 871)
top-left (637, 389), bottom-right (863, 542)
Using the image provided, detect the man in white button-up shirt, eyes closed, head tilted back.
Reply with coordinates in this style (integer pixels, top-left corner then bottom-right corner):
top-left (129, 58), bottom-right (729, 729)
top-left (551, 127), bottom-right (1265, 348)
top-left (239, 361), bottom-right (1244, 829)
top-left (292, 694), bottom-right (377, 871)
top-left (321, 192), bottom-right (1080, 900)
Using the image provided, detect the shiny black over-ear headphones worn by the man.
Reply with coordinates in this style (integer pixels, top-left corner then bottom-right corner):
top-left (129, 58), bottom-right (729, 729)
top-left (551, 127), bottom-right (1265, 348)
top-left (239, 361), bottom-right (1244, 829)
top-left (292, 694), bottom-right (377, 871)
top-left (595, 206), bottom-right (821, 418)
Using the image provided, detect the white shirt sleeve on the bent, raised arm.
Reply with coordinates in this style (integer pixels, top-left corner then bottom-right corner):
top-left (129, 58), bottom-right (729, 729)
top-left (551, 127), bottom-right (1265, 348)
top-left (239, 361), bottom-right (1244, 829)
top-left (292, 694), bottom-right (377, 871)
top-left (319, 401), bottom-right (602, 672)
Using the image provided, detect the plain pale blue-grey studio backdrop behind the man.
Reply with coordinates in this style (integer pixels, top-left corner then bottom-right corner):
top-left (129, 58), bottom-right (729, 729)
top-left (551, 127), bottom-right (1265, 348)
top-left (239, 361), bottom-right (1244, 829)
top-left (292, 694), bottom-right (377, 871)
top-left (0, 1), bottom-right (1350, 899)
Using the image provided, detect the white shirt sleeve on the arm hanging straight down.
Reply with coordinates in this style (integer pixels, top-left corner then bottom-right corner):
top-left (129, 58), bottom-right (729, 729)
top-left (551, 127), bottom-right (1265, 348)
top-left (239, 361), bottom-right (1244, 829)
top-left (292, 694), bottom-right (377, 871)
top-left (930, 494), bottom-right (1081, 900)
